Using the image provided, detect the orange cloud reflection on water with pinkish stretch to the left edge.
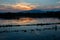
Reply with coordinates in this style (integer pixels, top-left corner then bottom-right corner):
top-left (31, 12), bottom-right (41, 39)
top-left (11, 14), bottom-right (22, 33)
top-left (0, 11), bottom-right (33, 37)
top-left (0, 17), bottom-right (37, 25)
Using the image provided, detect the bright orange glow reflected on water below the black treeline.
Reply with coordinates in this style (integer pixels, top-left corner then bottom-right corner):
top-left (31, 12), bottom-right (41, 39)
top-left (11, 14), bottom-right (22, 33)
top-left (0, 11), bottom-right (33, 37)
top-left (18, 17), bottom-right (36, 25)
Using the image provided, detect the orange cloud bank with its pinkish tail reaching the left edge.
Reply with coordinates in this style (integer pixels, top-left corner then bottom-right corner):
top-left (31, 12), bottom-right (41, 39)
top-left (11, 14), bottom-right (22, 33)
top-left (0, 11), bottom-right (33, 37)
top-left (0, 2), bottom-right (39, 11)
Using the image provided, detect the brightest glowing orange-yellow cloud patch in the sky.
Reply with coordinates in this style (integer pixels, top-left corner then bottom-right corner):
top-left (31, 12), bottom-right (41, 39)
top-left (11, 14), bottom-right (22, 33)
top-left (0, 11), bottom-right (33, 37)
top-left (12, 3), bottom-right (36, 10)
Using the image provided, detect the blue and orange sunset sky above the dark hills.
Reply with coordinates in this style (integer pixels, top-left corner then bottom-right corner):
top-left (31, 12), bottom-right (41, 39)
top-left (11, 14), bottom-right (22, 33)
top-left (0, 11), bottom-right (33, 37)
top-left (0, 0), bottom-right (60, 12)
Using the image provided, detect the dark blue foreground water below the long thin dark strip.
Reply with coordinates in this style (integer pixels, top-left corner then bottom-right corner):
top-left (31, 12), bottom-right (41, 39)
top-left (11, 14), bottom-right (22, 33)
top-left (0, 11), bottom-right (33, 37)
top-left (0, 25), bottom-right (60, 40)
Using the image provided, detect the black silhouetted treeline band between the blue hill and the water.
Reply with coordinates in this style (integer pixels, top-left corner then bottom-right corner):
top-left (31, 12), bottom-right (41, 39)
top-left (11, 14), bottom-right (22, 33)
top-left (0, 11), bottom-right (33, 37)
top-left (0, 11), bottom-right (60, 19)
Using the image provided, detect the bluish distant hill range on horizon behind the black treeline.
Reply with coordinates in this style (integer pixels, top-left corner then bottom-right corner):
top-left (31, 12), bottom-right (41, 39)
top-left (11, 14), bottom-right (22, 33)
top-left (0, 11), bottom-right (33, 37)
top-left (0, 9), bottom-right (60, 13)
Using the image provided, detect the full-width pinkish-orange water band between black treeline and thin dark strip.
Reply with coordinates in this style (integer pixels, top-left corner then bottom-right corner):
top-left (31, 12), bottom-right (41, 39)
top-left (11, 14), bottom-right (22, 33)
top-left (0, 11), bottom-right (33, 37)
top-left (0, 17), bottom-right (60, 25)
